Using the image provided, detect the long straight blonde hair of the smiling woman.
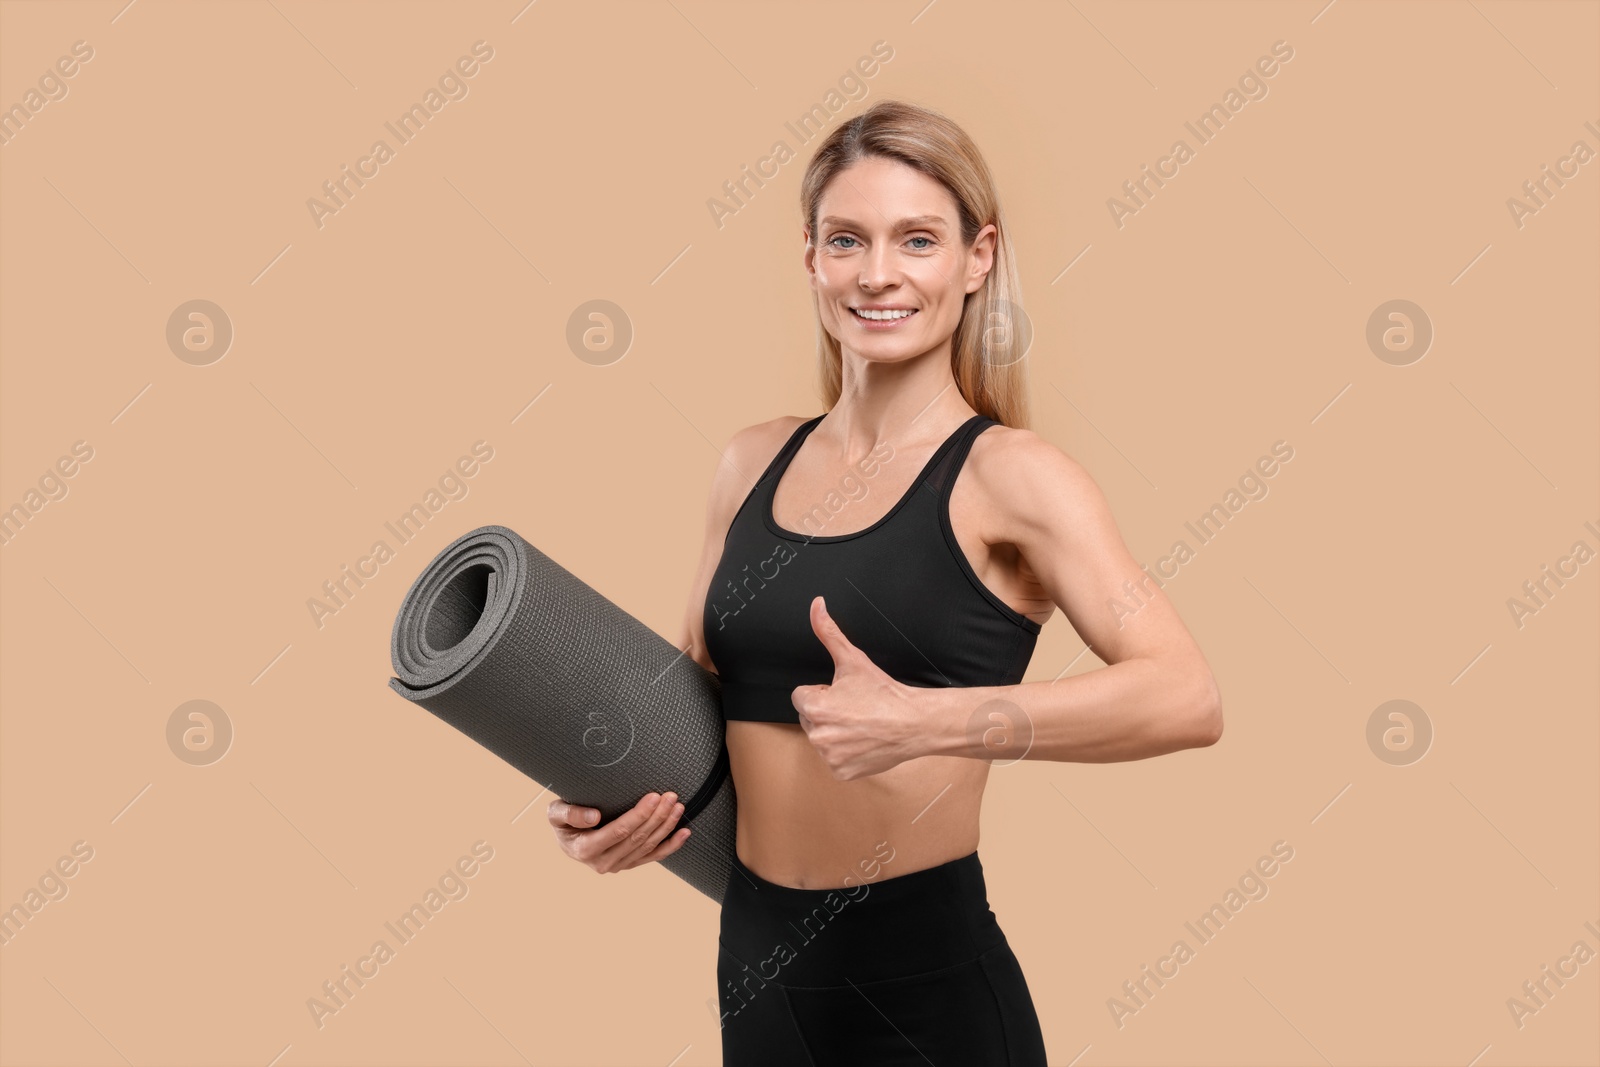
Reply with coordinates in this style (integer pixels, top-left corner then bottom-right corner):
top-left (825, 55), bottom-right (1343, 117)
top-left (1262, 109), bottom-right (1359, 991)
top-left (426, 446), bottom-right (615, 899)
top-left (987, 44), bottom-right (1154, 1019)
top-left (800, 99), bottom-right (1027, 427)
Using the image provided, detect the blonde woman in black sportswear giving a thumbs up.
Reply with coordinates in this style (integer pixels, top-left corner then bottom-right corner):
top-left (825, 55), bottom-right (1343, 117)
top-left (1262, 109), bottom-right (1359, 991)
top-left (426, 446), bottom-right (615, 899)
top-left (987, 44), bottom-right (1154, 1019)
top-left (549, 101), bottom-right (1222, 1067)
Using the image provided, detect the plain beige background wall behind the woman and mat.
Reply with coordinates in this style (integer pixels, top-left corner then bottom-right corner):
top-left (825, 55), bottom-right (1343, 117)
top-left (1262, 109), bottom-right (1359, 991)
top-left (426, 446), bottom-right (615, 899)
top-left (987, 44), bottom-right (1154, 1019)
top-left (0, 0), bottom-right (1600, 1067)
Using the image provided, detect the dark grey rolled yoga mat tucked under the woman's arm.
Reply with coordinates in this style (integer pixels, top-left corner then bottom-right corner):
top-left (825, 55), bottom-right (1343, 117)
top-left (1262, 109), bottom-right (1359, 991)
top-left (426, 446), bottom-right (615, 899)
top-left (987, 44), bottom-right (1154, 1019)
top-left (389, 526), bottom-right (736, 904)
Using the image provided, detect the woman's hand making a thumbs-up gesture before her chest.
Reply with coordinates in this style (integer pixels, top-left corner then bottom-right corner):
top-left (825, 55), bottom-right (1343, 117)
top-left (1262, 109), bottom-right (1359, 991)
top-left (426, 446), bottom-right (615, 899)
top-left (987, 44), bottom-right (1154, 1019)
top-left (790, 597), bottom-right (920, 781)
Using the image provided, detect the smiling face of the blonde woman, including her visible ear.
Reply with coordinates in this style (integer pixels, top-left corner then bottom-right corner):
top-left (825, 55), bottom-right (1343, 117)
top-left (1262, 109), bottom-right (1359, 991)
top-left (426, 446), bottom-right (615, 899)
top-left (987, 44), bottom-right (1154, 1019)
top-left (805, 157), bottom-right (995, 363)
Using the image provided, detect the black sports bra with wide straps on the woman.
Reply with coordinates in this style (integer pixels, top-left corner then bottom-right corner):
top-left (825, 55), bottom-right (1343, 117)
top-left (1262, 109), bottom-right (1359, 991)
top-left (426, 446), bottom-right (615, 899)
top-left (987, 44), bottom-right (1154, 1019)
top-left (702, 413), bottom-right (1040, 723)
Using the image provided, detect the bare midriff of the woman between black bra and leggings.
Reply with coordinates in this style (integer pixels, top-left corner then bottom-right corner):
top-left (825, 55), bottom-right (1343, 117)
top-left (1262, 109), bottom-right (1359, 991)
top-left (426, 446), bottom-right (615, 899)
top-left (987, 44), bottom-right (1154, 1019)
top-left (726, 720), bottom-right (989, 889)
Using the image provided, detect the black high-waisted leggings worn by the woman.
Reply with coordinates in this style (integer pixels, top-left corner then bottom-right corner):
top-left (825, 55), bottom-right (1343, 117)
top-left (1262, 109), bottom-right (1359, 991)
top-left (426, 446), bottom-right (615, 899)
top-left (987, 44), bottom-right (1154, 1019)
top-left (717, 851), bottom-right (1045, 1067)
